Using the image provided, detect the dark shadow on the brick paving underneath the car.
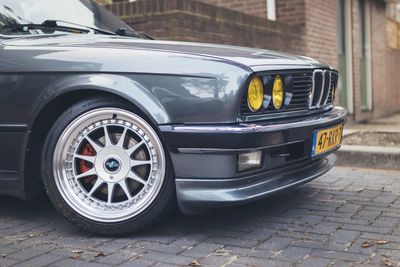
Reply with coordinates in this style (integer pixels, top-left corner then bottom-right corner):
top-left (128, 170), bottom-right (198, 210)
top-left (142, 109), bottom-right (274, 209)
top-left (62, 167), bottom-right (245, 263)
top-left (0, 185), bottom-right (318, 240)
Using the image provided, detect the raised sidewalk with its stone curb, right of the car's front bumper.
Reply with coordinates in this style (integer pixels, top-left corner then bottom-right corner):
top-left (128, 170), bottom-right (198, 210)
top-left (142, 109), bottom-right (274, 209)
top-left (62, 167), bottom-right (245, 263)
top-left (337, 114), bottom-right (400, 170)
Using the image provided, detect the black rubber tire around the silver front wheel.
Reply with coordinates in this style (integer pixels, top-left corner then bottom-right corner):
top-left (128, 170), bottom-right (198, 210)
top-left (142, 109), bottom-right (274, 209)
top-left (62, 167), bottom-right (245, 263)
top-left (41, 97), bottom-right (175, 235)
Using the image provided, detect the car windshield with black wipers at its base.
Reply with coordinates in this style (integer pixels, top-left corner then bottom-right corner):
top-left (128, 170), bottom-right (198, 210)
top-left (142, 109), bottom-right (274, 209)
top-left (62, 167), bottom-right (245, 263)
top-left (0, 0), bottom-right (135, 35)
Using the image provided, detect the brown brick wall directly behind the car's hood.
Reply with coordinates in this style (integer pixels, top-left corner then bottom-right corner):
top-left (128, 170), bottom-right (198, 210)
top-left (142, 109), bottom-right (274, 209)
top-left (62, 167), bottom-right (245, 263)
top-left (101, 0), bottom-right (338, 67)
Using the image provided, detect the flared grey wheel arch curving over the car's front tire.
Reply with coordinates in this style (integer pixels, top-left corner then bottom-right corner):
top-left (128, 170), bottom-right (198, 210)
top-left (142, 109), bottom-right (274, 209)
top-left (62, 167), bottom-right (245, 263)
top-left (22, 75), bottom-right (168, 199)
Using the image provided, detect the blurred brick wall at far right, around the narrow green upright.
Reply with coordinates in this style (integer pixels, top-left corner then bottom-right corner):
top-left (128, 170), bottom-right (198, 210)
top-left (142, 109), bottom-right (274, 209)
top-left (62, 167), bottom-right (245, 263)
top-left (340, 0), bottom-right (400, 121)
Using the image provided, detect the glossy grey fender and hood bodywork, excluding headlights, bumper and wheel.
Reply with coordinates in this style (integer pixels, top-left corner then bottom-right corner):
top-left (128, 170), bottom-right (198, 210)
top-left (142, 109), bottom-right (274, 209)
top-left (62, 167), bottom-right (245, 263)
top-left (0, 34), bottom-right (329, 203)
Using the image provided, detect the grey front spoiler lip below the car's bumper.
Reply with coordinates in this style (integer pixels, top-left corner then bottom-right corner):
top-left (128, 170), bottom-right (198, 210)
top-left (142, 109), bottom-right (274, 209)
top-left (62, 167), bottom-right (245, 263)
top-left (176, 154), bottom-right (337, 214)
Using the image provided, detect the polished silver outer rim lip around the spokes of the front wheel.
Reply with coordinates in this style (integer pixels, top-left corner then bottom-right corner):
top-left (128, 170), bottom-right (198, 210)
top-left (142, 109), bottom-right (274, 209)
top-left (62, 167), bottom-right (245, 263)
top-left (52, 107), bottom-right (167, 223)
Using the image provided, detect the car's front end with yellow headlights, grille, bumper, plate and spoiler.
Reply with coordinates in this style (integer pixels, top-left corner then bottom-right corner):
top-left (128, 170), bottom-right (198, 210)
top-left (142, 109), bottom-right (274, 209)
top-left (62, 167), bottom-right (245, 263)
top-left (161, 68), bottom-right (346, 213)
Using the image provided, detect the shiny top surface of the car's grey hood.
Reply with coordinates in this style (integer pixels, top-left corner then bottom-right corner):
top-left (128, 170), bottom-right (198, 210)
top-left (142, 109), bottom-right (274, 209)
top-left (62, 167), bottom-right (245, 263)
top-left (5, 35), bottom-right (322, 71)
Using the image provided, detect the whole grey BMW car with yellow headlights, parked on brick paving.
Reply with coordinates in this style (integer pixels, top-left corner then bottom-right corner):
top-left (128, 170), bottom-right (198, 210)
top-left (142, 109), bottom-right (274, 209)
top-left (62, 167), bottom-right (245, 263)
top-left (0, 0), bottom-right (346, 235)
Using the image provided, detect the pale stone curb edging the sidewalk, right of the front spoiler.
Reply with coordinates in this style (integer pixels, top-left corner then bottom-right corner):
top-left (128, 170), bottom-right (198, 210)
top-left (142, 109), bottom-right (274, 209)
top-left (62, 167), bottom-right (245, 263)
top-left (336, 145), bottom-right (400, 170)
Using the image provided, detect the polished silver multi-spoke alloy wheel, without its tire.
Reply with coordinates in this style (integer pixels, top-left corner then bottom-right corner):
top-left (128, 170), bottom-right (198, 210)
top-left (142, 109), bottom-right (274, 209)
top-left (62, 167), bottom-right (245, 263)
top-left (53, 108), bottom-right (166, 223)
